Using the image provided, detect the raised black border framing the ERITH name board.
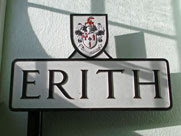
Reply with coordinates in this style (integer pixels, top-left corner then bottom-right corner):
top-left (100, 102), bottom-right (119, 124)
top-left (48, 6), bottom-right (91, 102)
top-left (9, 59), bottom-right (172, 111)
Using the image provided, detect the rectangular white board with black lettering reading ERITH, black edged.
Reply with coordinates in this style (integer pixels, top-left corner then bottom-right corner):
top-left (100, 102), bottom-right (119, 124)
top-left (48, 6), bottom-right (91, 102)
top-left (10, 59), bottom-right (172, 111)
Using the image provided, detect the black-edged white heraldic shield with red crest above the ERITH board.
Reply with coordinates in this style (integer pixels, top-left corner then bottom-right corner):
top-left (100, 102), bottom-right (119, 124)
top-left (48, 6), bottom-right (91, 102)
top-left (70, 14), bottom-right (108, 58)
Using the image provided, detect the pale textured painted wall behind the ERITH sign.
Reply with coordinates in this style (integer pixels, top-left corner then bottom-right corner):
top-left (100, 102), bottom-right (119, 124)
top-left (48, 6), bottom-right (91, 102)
top-left (0, 0), bottom-right (181, 136)
